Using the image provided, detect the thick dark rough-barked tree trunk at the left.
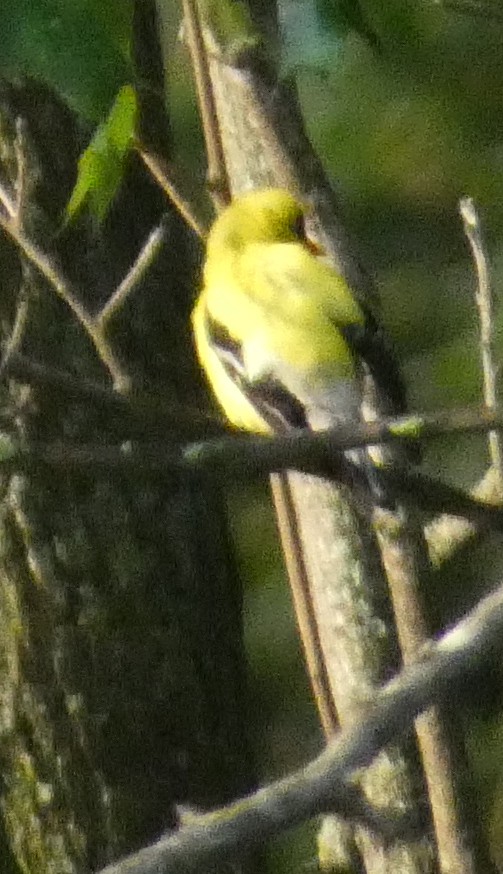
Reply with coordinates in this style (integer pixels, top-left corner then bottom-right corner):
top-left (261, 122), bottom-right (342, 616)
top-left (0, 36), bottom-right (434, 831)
top-left (0, 76), bottom-right (252, 874)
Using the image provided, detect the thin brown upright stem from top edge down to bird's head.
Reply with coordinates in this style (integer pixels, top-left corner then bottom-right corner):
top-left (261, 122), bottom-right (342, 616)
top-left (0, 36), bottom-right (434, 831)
top-left (183, 0), bottom-right (230, 209)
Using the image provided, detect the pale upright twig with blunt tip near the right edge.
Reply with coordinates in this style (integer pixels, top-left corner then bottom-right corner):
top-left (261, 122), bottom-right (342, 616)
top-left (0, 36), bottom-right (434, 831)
top-left (459, 197), bottom-right (503, 491)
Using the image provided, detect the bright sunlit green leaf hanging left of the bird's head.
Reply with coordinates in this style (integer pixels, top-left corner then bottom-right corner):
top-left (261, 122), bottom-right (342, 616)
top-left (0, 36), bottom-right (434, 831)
top-left (66, 85), bottom-right (138, 222)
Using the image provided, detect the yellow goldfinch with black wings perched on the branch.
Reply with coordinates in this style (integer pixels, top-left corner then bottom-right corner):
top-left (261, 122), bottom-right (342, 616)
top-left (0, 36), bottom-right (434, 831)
top-left (192, 188), bottom-right (404, 490)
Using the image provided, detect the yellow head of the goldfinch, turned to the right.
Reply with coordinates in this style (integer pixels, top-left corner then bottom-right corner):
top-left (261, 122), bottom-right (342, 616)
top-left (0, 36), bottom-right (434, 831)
top-left (208, 188), bottom-right (314, 254)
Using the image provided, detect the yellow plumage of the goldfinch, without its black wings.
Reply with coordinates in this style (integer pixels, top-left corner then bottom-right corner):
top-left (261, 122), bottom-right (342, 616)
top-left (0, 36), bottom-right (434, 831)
top-left (193, 189), bottom-right (365, 431)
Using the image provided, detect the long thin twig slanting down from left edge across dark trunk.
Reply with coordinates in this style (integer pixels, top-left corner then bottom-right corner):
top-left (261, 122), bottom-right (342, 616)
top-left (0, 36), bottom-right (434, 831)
top-left (0, 213), bottom-right (131, 394)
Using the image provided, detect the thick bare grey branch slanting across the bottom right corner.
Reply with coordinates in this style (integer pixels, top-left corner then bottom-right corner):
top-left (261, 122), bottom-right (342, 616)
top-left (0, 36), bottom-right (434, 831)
top-left (95, 587), bottom-right (503, 874)
